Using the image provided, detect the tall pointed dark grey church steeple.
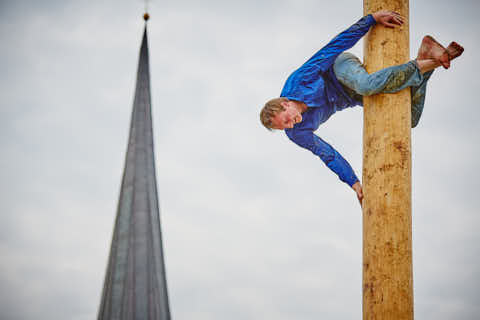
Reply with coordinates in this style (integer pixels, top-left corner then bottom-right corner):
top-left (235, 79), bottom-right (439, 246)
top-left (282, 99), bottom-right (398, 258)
top-left (98, 18), bottom-right (170, 320)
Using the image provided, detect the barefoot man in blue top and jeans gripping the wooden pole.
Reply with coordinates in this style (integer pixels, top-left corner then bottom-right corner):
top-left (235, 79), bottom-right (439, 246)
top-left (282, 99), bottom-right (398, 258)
top-left (260, 10), bottom-right (463, 204)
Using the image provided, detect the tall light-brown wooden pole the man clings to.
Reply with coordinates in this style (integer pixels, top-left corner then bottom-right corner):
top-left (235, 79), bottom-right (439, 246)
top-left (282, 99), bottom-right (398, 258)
top-left (363, 0), bottom-right (413, 320)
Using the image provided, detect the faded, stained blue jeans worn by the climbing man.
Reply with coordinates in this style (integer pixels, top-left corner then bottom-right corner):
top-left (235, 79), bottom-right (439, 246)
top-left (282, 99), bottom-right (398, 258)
top-left (333, 52), bottom-right (433, 128)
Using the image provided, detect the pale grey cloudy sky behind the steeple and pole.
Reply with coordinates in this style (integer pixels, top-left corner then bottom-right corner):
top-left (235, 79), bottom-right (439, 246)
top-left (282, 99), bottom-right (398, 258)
top-left (0, 0), bottom-right (480, 320)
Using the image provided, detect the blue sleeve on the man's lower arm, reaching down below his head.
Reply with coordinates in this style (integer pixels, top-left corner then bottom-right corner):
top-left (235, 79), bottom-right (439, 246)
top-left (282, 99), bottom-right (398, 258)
top-left (286, 130), bottom-right (359, 187)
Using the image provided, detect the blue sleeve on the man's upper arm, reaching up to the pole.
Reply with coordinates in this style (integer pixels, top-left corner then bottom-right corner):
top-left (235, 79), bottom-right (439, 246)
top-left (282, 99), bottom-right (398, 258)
top-left (300, 14), bottom-right (376, 76)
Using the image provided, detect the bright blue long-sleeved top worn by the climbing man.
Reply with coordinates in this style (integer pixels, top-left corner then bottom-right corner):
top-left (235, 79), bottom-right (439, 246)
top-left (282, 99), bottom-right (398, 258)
top-left (280, 15), bottom-right (375, 186)
